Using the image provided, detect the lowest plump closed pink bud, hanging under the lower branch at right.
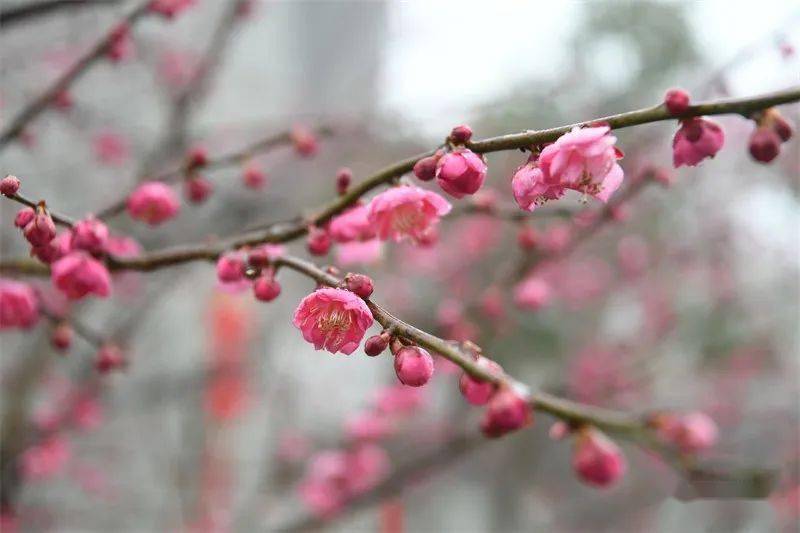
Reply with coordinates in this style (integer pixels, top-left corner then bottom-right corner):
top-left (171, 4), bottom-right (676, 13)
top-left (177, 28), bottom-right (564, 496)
top-left (572, 428), bottom-right (627, 487)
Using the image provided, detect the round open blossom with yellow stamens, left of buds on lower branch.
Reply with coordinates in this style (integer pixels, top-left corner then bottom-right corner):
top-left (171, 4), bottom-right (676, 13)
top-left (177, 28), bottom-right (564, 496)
top-left (292, 287), bottom-right (373, 355)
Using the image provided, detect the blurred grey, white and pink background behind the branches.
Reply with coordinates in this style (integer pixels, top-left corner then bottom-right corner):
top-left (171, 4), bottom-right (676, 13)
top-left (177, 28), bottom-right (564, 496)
top-left (0, 0), bottom-right (800, 531)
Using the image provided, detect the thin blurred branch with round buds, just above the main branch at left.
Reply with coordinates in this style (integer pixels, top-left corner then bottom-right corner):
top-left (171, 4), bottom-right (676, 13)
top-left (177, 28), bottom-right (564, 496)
top-left (96, 126), bottom-right (333, 220)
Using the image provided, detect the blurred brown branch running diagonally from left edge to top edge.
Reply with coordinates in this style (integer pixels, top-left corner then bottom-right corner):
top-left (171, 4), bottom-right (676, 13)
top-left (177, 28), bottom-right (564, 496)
top-left (0, 0), bottom-right (150, 151)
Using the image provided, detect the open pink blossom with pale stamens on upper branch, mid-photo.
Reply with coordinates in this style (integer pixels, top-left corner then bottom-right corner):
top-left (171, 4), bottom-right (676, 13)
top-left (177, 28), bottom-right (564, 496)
top-left (367, 185), bottom-right (452, 242)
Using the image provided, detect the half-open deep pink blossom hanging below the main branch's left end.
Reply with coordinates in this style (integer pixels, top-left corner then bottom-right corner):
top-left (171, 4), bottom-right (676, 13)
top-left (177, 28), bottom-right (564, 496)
top-left (50, 251), bottom-right (111, 300)
